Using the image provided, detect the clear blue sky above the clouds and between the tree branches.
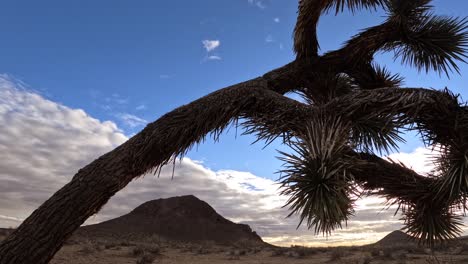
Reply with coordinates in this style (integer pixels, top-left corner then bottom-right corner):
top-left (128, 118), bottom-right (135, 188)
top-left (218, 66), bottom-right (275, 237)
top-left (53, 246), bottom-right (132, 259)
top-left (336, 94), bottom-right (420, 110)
top-left (0, 0), bottom-right (468, 179)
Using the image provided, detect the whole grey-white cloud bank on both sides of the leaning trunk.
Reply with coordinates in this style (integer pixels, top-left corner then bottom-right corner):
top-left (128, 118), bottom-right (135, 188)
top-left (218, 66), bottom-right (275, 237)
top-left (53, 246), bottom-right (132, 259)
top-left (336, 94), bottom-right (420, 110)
top-left (0, 76), bottom-right (454, 246)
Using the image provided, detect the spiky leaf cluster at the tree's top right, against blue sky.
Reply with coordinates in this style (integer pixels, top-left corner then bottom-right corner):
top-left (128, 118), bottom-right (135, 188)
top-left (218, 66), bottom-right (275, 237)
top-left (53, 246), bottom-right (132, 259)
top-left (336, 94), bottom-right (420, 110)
top-left (384, 0), bottom-right (468, 75)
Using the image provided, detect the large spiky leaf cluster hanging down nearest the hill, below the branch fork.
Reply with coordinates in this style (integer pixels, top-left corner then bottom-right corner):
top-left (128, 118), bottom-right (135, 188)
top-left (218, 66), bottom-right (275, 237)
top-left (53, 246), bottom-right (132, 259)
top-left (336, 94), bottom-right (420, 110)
top-left (280, 116), bottom-right (357, 234)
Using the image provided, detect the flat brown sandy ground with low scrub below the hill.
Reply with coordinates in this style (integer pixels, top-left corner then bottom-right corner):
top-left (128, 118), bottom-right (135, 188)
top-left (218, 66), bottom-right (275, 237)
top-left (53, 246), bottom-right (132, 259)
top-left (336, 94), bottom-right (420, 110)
top-left (46, 242), bottom-right (468, 264)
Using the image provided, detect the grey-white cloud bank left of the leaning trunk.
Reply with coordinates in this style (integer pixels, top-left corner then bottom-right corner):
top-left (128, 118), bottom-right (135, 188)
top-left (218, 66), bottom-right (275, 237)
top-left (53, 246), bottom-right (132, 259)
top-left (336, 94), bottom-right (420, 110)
top-left (0, 75), bottom-right (127, 226)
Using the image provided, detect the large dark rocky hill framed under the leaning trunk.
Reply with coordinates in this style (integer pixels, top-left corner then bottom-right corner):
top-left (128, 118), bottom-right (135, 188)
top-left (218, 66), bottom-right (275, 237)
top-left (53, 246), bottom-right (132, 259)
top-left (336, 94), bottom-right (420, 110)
top-left (76, 195), bottom-right (266, 244)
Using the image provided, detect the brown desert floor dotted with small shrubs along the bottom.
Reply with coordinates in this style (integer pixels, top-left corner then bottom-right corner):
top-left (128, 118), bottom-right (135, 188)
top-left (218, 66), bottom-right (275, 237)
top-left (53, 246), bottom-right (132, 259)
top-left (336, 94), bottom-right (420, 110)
top-left (0, 230), bottom-right (468, 264)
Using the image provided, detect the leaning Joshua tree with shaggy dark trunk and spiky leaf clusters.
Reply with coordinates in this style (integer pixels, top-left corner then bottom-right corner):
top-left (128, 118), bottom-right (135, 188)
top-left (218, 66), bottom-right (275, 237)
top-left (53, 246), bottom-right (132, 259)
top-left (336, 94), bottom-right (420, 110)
top-left (0, 0), bottom-right (468, 264)
